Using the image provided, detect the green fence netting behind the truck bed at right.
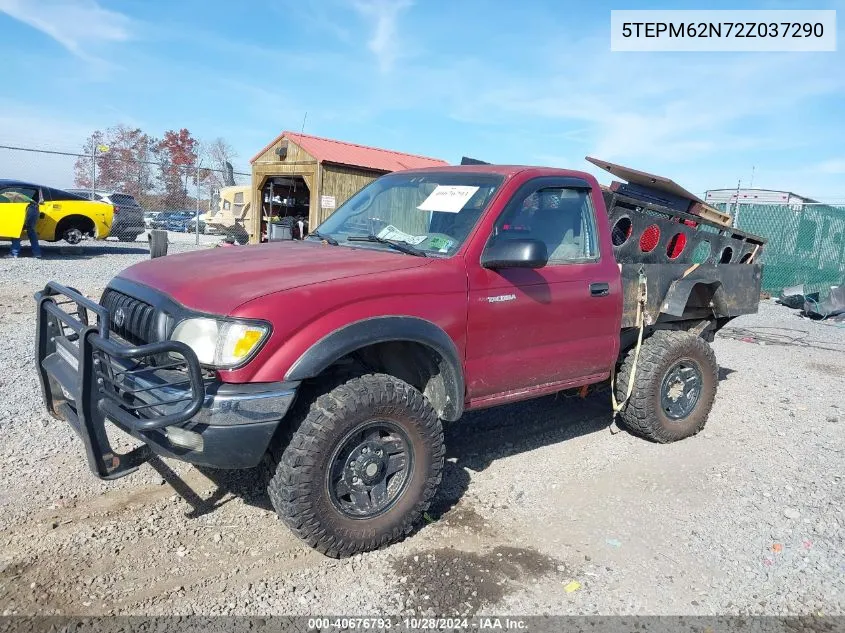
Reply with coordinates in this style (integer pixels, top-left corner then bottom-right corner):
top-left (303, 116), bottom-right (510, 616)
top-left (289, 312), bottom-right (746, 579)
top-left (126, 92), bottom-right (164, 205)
top-left (717, 204), bottom-right (845, 294)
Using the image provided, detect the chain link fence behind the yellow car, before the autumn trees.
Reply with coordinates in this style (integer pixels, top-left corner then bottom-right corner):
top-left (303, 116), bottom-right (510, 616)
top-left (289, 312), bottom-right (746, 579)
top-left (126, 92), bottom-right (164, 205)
top-left (0, 145), bottom-right (251, 240)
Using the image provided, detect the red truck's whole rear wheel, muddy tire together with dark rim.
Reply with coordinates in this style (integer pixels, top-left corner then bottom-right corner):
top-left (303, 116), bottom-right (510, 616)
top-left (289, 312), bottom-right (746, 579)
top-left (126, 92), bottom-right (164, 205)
top-left (616, 330), bottom-right (719, 443)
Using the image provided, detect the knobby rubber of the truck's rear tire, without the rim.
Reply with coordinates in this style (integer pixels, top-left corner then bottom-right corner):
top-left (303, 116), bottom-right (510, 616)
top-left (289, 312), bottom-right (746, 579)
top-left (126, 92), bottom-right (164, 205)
top-left (616, 330), bottom-right (719, 444)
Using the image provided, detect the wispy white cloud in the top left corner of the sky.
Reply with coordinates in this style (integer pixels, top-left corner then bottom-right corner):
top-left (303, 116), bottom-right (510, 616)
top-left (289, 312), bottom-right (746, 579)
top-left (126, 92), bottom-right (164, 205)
top-left (0, 0), bottom-right (131, 60)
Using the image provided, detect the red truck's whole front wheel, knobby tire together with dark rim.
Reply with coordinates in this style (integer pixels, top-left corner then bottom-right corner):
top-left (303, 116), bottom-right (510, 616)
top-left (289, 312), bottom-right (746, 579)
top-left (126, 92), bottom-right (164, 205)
top-left (268, 374), bottom-right (444, 558)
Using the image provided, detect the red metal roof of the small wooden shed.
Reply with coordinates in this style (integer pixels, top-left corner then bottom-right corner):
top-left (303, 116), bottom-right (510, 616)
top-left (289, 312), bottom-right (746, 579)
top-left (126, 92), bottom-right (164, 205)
top-left (250, 131), bottom-right (448, 172)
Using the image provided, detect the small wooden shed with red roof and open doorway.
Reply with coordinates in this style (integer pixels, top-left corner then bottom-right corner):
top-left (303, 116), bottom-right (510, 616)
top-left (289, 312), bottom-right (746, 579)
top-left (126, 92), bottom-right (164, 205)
top-left (249, 131), bottom-right (447, 241)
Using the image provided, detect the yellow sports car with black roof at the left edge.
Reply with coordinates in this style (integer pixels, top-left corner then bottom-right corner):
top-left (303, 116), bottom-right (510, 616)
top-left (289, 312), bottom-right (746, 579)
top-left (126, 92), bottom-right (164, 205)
top-left (0, 179), bottom-right (114, 244)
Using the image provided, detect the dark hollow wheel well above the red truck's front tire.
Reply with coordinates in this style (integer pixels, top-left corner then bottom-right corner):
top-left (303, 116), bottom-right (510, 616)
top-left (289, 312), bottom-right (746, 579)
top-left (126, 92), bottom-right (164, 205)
top-left (306, 341), bottom-right (463, 420)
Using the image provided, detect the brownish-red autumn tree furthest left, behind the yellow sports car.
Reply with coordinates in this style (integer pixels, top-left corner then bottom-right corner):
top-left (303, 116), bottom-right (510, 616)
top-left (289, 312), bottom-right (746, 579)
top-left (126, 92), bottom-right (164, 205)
top-left (74, 125), bottom-right (156, 196)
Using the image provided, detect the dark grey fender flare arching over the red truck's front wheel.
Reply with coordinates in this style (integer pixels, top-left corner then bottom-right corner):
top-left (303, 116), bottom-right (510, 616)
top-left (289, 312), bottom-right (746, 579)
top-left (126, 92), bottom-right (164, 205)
top-left (285, 316), bottom-right (465, 421)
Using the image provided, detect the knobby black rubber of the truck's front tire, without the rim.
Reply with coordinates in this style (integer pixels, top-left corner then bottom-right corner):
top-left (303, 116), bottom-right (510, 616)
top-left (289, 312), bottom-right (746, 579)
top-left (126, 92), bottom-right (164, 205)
top-left (268, 374), bottom-right (445, 558)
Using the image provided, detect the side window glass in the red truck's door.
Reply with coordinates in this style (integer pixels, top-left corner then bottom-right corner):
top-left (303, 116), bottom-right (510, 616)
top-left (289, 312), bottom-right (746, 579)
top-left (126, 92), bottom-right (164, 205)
top-left (492, 186), bottom-right (599, 264)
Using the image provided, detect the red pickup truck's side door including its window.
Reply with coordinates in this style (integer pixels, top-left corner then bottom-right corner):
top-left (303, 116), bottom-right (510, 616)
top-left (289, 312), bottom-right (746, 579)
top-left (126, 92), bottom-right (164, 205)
top-left (466, 177), bottom-right (622, 400)
